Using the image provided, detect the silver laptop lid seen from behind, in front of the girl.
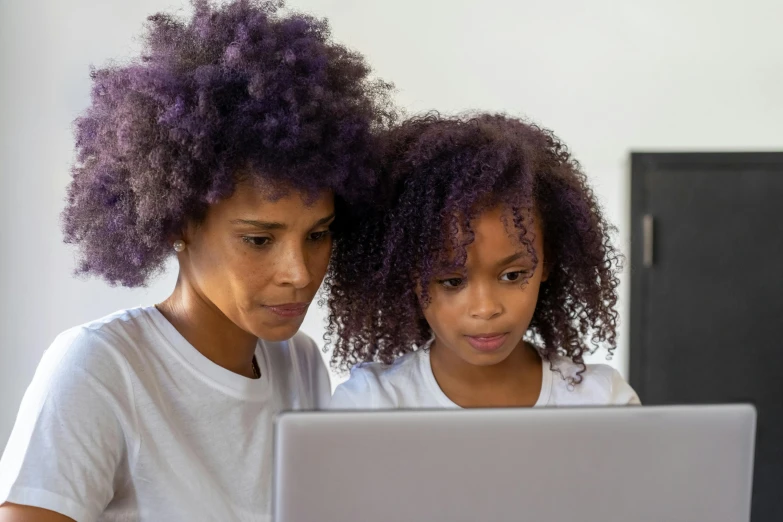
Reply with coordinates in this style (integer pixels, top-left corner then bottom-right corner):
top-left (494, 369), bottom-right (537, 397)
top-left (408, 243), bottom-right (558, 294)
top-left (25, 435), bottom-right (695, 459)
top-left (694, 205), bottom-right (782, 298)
top-left (273, 405), bottom-right (756, 522)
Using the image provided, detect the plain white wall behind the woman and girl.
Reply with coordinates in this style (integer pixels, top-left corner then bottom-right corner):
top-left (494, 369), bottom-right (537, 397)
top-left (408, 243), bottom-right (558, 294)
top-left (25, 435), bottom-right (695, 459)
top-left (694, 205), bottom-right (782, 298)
top-left (0, 0), bottom-right (783, 448)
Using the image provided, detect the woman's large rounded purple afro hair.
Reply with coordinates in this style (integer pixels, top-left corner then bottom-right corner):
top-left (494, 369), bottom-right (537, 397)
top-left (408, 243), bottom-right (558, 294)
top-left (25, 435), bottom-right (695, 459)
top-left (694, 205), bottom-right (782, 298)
top-left (62, 0), bottom-right (394, 287)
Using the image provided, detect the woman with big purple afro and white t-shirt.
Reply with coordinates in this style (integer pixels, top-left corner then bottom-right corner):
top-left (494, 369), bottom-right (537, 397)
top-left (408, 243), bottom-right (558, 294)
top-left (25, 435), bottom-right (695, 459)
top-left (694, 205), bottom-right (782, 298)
top-left (0, 0), bottom-right (389, 522)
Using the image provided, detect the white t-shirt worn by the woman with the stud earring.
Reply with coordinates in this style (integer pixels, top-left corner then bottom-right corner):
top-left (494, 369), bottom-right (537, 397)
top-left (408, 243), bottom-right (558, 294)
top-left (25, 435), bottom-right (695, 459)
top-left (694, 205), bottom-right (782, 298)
top-left (0, 307), bottom-right (330, 522)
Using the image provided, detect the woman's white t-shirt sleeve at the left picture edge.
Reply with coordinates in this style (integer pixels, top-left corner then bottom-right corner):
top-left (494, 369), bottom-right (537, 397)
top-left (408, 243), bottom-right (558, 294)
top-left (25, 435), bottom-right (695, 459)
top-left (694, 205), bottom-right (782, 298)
top-left (0, 328), bottom-right (135, 522)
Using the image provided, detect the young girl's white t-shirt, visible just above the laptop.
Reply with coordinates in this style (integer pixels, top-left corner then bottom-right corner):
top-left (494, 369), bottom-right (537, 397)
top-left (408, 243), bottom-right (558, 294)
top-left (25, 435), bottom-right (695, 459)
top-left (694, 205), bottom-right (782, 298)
top-left (329, 348), bottom-right (639, 409)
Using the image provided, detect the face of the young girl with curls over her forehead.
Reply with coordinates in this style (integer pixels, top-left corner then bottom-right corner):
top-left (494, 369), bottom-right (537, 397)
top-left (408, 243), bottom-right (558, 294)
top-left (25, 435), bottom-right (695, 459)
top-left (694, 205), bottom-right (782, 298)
top-left (423, 208), bottom-right (547, 366)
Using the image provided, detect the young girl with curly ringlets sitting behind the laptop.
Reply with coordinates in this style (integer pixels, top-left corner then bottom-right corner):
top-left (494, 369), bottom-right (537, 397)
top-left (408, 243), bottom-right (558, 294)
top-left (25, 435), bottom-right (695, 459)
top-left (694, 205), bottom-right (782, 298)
top-left (329, 115), bottom-right (639, 408)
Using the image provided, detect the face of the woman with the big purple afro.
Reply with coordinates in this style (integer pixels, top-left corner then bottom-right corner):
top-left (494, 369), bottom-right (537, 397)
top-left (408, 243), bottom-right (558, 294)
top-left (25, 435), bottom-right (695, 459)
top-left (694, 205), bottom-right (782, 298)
top-left (179, 182), bottom-right (334, 341)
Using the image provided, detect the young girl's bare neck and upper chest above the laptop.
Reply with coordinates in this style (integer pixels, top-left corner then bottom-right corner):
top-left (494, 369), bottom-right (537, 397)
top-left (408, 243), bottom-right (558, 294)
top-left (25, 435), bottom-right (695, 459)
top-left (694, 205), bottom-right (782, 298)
top-left (430, 339), bottom-right (543, 408)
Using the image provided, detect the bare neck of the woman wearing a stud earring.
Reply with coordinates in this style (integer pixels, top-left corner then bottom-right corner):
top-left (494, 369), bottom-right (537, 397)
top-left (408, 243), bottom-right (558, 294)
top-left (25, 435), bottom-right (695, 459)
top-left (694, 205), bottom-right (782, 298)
top-left (157, 278), bottom-right (258, 378)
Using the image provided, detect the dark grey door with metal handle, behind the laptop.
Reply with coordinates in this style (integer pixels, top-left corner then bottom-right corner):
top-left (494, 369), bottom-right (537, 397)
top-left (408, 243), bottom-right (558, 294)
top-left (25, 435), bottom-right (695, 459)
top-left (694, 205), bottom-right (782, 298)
top-left (630, 153), bottom-right (783, 522)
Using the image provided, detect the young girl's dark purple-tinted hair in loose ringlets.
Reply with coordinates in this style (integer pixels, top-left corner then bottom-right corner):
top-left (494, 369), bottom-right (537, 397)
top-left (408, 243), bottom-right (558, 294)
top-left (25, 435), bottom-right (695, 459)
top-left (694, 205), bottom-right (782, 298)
top-left (327, 114), bottom-right (620, 373)
